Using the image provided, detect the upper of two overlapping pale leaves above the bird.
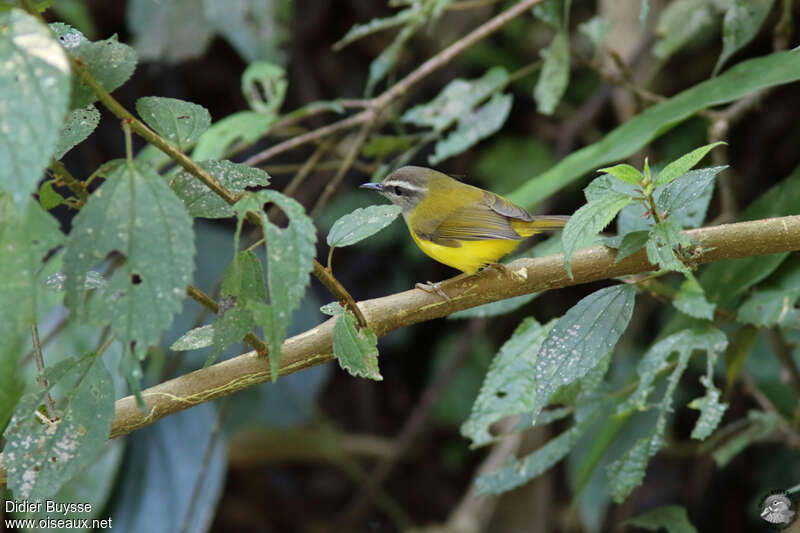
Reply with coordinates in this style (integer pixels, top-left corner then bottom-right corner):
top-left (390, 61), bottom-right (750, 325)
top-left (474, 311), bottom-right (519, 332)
top-left (402, 67), bottom-right (508, 131)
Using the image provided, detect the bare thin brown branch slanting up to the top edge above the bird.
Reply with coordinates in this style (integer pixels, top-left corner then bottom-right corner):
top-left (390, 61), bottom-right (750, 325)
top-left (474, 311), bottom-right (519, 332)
top-left (244, 0), bottom-right (542, 166)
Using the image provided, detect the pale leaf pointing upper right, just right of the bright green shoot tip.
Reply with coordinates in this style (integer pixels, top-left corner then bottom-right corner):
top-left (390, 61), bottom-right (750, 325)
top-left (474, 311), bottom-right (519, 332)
top-left (655, 166), bottom-right (728, 228)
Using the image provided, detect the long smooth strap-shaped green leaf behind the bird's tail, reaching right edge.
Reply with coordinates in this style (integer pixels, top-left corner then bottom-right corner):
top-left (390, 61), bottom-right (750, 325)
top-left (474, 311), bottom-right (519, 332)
top-left (507, 51), bottom-right (800, 208)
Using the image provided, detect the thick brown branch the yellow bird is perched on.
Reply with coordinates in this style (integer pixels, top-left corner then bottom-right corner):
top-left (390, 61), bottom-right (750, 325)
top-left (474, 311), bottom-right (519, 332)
top-left (111, 215), bottom-right (800, 437)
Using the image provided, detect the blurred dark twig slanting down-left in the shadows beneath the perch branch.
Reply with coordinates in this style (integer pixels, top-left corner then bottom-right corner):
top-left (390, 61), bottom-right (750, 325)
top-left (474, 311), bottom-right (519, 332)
top-left (342, 318), bottom-right (486, 529)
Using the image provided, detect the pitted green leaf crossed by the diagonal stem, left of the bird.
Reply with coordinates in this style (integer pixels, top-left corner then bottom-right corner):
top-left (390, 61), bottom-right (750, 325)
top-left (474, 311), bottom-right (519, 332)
top-left (169, 160), bottom-right (270, 218)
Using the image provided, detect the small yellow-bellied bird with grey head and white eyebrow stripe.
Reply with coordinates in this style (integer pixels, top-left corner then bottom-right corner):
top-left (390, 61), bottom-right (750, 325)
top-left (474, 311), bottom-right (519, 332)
top-left (361, 166), bottom-right (569, 299)
